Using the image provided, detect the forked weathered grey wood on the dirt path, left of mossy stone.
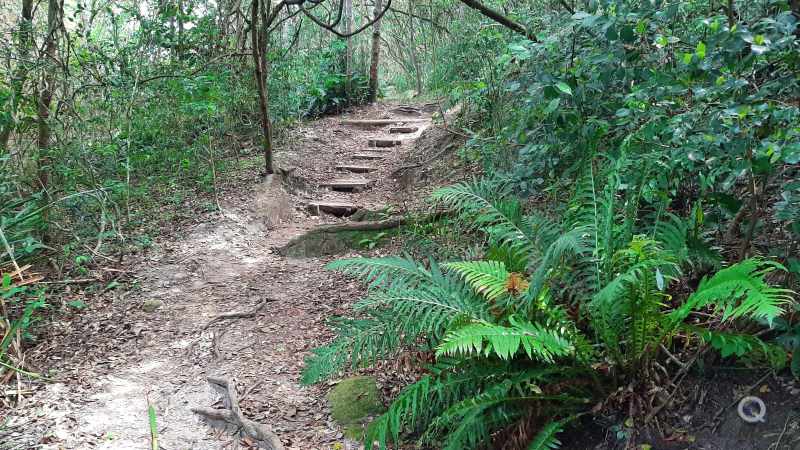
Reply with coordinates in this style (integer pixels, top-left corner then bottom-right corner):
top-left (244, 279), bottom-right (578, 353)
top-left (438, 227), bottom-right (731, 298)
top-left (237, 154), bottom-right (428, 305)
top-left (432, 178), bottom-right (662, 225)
top-left (192, 377), bottom-right (284, 450)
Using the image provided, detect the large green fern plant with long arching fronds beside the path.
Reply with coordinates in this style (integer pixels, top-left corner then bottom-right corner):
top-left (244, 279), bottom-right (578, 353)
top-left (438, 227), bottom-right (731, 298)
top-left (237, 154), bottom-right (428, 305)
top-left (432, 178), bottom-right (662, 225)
top-left (304, 173), bottom-right (793, 449)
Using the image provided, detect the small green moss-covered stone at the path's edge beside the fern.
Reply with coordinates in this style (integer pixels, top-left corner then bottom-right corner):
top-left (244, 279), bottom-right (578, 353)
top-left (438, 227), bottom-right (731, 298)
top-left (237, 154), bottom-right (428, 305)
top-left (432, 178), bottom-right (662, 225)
top-left (328, 376), bottom-right (386, 439)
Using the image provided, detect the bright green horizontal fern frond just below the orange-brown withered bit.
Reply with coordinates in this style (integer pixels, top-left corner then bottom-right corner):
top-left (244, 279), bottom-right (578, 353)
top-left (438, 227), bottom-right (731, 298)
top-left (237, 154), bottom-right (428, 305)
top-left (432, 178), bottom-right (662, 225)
top-left (436, 317), bottom-right (574, 362)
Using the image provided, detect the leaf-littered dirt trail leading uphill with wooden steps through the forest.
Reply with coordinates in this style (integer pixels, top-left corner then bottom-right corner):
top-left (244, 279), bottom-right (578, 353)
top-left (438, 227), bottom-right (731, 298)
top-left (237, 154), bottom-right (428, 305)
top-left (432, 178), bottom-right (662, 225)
top-left (0, 104), bottom-right (429, 450)
